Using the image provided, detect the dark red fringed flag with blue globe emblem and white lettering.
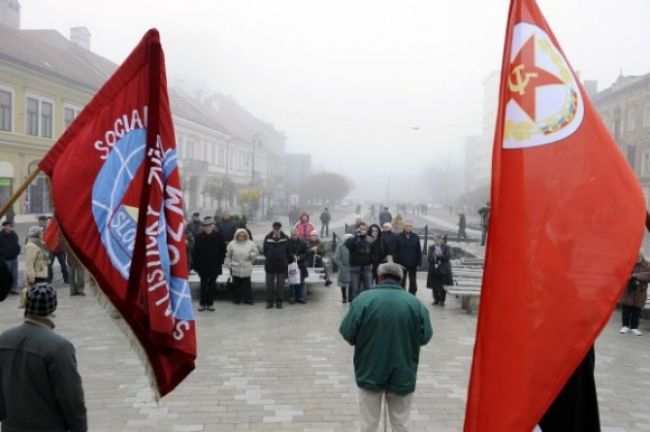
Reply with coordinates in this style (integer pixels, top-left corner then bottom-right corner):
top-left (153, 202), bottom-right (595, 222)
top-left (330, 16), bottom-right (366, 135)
top-left (39, 29), bottom-right (196, 396)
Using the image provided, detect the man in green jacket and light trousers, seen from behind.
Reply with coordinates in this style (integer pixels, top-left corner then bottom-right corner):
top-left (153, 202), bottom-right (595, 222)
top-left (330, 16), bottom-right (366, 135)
top-left (339, 262), bottom-right (432, 432)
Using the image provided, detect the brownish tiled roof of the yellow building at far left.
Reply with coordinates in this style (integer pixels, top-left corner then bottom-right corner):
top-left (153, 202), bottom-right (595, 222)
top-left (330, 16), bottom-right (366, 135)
top-left (0, 24), bottom-right (117, 89)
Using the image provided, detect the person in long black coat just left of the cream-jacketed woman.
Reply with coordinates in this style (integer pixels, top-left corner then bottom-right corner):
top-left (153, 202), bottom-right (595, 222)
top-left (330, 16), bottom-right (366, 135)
top-left (192, 218), bottom-right (226, 312)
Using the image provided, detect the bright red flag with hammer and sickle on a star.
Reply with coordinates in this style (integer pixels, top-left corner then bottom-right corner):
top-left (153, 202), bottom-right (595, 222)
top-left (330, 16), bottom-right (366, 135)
top-left (465, 0), bottom-right (645, 432)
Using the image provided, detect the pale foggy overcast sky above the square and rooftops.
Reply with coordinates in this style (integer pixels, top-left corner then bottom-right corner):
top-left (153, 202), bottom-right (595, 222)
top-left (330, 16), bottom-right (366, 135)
top-left (20, 0), bottom-right (650, 197)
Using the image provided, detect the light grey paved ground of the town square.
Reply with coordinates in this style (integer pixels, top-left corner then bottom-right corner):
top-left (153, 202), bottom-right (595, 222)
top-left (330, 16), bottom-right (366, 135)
top-left (0, 275), bottom-right (650, 432)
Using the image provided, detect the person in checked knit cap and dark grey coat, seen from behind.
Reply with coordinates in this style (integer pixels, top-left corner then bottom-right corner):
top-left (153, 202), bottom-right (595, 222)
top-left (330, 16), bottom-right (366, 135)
top-left (0, 283), bottom-right (88, 432)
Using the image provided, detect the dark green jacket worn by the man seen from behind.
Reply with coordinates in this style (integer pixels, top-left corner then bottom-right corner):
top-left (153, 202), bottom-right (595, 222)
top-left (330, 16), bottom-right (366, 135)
top-left (339, 284), bottom-right (432, 395)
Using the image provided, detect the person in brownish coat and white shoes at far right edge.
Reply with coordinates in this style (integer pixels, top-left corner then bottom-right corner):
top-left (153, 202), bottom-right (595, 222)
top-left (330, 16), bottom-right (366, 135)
top-left (621, 252), bottom-right (650, 336)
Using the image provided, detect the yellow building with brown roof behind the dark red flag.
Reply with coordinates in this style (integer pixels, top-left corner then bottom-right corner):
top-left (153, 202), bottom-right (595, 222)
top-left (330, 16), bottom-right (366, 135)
top-left (0, 0), bottom-right (115, 214)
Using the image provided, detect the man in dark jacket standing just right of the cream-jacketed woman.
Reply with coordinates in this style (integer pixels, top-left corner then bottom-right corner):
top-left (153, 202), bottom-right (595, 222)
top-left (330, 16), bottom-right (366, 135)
top-left (262, 222), bottom-right (293, 309)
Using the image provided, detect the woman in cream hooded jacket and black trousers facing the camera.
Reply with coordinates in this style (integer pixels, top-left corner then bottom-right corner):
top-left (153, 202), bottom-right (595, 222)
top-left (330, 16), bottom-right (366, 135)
top-left (224, 228), bottom-right (259, 305)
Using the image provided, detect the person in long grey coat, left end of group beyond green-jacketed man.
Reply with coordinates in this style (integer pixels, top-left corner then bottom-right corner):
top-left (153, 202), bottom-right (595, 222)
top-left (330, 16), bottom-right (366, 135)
top-left (345, 223), bottom-right (373, 301)
